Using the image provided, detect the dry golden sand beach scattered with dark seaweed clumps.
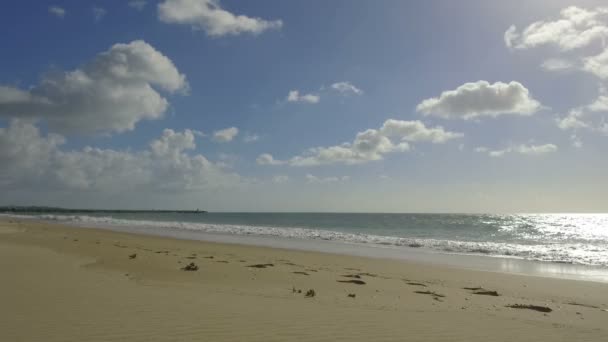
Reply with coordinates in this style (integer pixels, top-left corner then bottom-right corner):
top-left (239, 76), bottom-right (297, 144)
top-left (0, 219), bottom-right (608, 342)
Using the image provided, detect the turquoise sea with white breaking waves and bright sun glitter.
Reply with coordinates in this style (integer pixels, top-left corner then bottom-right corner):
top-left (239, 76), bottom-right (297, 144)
top-left (4, 212), bottom-right (608, 267)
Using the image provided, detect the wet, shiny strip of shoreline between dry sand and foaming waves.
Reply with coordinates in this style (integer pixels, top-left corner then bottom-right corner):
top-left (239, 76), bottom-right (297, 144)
top-left (5, 215), bottom-right (608, 283)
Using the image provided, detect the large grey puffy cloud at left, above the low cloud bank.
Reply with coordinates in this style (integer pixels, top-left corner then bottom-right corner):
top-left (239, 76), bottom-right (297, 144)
top-left (0, 40), bottom-right (188, 134)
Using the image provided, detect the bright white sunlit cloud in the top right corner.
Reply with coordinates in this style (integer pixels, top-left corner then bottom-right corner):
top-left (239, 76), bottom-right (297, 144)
top-left (504, 6), bottom-right (608, 51)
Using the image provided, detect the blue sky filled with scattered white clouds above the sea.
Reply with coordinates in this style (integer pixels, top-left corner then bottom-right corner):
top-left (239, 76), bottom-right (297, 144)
top-left (0, 0), bottom-right (608, 212)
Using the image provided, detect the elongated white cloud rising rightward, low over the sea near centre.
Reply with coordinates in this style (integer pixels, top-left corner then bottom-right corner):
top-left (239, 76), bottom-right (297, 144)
top-left (257, 119), bottom-right (463, 166)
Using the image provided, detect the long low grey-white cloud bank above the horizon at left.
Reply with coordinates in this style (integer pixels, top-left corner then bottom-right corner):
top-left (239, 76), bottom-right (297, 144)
top-left (0, 120), bottom-right (242, 192)
